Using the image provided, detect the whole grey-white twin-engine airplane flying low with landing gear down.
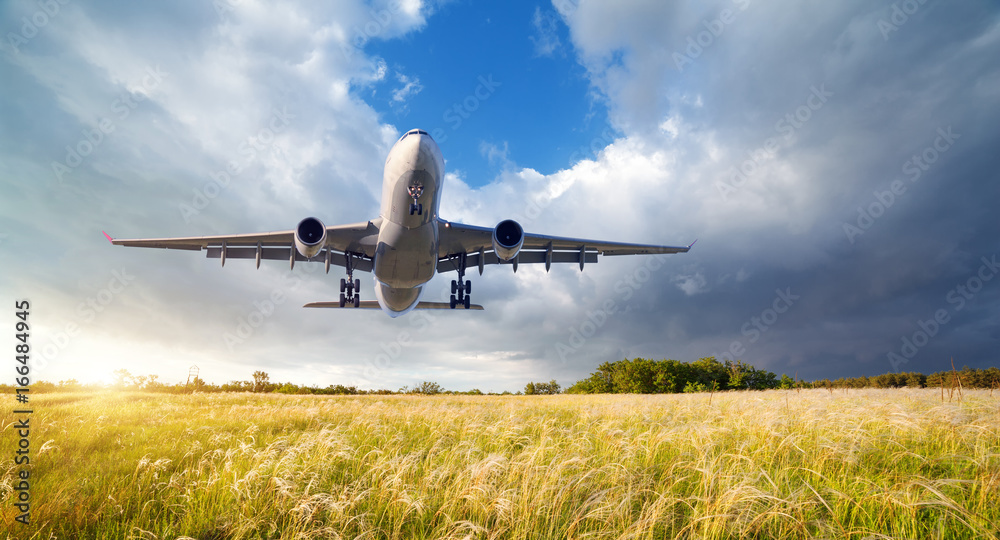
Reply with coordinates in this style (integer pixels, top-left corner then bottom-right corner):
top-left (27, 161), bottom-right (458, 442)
top-left (104, 129), bottom-right (694, 318)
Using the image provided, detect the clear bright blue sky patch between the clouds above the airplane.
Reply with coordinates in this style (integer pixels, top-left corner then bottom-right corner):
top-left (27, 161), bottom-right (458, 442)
top-left (364, 2), bottom-right (609, 187)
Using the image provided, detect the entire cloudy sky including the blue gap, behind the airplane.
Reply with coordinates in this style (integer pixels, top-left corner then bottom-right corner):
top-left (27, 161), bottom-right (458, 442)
top-left (0, 0), bottom-right (1000, 391)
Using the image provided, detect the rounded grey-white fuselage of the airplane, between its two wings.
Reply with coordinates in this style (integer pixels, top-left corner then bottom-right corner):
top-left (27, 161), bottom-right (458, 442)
top-left (373, 130), bottom-right (444, 317)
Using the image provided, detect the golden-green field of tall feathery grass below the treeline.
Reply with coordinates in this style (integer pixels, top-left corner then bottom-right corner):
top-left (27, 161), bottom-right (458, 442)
top-left (0, 389), bottom-right (1000, 540)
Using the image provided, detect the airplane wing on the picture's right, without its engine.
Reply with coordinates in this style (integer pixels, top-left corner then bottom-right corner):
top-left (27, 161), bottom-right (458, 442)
top-left (437, 222), bottom-right (694, 274)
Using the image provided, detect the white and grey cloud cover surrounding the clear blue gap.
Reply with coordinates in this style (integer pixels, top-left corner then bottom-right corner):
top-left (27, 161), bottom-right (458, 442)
top-left (0, 0), bottom-right (1000, 390)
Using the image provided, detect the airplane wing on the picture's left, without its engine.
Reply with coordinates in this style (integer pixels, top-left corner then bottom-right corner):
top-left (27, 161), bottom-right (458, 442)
top-left (104, 218), bottom-right (382, 272)
